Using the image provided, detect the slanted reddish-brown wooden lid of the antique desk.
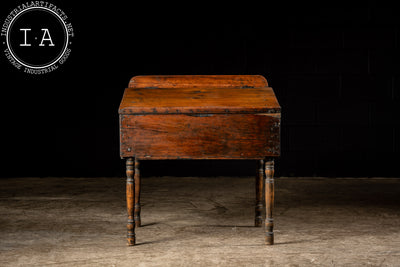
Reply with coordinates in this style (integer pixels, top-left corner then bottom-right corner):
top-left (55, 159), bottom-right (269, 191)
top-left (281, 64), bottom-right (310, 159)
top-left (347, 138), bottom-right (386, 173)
top-left (119, 87), bottom-right (280, 114)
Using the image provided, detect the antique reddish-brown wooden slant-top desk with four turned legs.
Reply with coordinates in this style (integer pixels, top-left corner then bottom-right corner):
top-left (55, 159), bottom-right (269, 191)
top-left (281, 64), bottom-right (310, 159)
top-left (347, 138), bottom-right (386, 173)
top-left (119, 75), bottom-right (281, 246)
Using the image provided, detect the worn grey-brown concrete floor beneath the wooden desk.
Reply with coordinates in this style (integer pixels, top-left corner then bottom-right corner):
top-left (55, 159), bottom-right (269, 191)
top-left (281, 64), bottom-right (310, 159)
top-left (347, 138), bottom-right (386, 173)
top-left (0, 177), bottom-right (400, 266)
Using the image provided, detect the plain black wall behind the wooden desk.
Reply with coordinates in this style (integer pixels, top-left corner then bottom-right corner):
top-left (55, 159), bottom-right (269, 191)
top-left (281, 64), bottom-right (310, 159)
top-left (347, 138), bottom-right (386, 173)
top-left (0, 1), bottom-right (400, 177)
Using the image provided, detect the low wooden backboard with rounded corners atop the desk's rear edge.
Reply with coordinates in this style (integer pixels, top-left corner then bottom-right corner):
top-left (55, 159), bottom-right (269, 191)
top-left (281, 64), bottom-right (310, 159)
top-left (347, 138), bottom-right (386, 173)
top-left (128, 75), bottom-right (268, 88)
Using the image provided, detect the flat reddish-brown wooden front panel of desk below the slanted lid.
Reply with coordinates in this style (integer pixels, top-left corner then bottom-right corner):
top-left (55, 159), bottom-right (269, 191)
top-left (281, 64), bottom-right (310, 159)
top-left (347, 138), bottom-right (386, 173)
top-left (120, 114), bottom-right (280, 159)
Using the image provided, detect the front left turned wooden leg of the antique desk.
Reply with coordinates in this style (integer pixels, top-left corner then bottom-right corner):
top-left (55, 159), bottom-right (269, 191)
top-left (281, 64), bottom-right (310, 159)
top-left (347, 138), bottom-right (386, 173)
top-left (126, 158), bottom-right (136, 246)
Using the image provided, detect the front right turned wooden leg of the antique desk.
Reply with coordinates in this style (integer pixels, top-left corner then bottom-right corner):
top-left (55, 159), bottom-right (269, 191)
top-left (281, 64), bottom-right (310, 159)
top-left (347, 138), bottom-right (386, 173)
top-left (265, 159), bottom-right (274, 245)
